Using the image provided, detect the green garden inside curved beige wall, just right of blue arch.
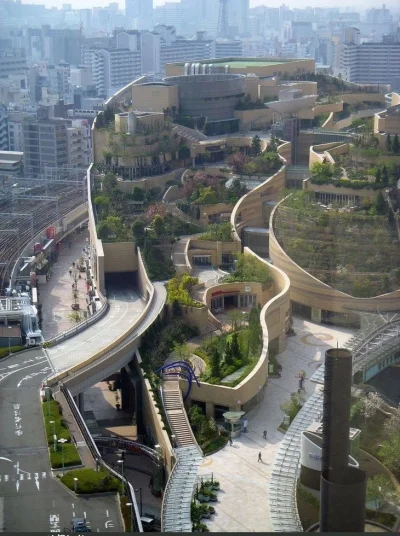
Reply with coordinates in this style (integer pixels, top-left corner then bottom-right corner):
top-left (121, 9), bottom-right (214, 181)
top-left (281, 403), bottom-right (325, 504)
top-left (195, 307), bottom-right (262, 387)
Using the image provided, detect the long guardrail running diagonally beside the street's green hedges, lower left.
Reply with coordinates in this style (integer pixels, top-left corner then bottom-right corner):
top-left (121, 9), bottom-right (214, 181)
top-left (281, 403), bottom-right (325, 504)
top-left (60, 383), bottom-right (143, 532)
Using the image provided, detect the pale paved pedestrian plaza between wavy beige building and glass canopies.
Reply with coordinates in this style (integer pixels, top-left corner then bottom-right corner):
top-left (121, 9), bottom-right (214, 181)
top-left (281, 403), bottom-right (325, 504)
top-left (199, 318), bottom-right (352, 532)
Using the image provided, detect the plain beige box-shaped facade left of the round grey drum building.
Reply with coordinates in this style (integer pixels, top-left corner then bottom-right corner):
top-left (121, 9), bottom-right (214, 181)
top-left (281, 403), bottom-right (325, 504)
top-left (132, 84), bottom-right (179, 112)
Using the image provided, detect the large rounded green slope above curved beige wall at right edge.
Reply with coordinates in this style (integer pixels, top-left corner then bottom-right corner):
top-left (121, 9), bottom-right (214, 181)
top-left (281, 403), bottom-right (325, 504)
top-left (274, 191), bottom-right (400, 298)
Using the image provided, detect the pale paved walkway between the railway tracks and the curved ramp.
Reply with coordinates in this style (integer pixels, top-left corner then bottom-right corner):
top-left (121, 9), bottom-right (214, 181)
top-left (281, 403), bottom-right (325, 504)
top-left (39, 230), bottom-right (89, 340)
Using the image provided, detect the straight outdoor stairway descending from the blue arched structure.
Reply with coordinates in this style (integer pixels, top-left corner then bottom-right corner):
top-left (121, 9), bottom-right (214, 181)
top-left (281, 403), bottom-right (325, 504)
top-left (162, 376), bottom-right (197, 448)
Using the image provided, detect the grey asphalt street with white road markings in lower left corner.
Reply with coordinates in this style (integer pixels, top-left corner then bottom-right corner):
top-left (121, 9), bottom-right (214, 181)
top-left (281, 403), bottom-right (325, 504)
top-left (0, 348), bottom-right (123, 532)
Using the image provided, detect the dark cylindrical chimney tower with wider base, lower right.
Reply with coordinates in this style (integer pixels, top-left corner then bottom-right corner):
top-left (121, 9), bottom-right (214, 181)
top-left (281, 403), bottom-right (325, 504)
top-left (320, 348), bottom-right (366, 532)
